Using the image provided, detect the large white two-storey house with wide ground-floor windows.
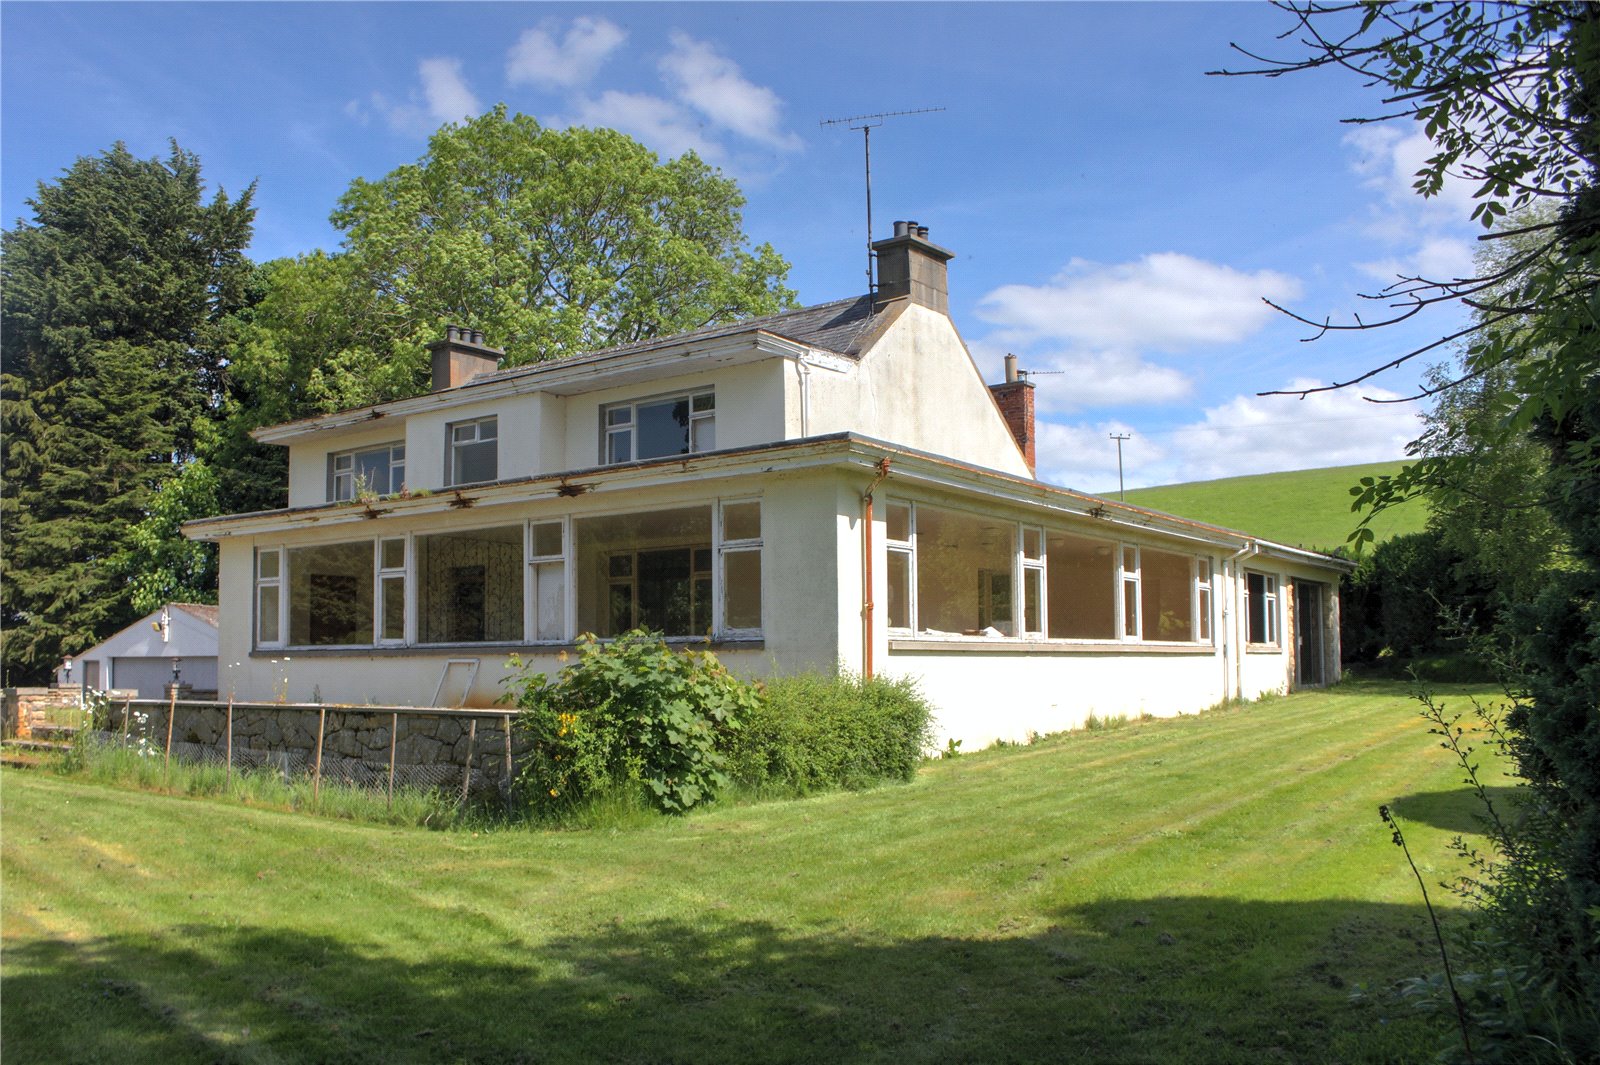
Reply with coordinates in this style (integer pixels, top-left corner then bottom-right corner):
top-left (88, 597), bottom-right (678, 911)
top-left (187, 222), bottom-right (1344, 747)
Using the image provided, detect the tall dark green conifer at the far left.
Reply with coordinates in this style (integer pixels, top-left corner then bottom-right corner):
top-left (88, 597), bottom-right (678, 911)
top-left (0, 142), bottom-right (254, 683)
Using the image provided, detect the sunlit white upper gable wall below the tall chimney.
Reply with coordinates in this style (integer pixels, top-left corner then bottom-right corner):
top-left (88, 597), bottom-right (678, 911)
top-left (786, 305), bottom-right (1032, 477)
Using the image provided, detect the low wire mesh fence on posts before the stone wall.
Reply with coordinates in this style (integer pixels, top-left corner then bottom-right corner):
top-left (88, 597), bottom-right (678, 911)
top-left (93, 697), bottom-right (526, 798)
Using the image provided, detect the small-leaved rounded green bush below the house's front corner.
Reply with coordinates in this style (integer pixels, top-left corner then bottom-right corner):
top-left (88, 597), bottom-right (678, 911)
top-left (730, 673), bottom-right (933, 795)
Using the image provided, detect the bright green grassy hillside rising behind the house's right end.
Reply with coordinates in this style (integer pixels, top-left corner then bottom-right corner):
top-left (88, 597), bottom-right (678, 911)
top-left (1110, 462), bottom-right (1427, 550)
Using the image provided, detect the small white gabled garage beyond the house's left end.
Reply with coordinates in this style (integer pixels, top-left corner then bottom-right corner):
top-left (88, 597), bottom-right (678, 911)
top-left (56, 603), bottom-right (218, 699)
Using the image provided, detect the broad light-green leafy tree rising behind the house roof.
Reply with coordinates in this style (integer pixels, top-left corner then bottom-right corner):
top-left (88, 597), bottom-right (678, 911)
top-left (232, 107), bottom-right (794, 429)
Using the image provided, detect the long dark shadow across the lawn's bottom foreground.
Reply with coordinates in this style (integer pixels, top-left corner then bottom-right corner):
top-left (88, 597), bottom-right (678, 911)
top-left (3, 897), bottom-right (1465, 1065)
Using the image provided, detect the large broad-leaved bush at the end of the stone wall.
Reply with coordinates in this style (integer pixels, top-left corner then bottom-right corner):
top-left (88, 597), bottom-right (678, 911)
top-left (509, 632), bottom-right (762, 814)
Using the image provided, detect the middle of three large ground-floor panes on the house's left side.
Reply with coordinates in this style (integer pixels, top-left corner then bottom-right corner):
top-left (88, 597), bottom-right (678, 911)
top-left (414, 525), bottom-right (523, 643)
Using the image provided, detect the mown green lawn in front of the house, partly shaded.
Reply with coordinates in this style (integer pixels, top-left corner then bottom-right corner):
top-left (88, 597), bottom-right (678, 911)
top-left (0, 684), bottom-right (1494, 1065)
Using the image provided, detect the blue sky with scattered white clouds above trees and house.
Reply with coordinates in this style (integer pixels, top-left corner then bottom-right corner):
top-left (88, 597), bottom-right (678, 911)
top-left (0, 0), bottom-right (1475, 491)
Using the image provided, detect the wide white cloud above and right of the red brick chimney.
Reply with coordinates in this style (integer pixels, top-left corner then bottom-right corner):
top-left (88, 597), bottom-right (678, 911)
top-left (978, 251), bottom-right (1301, 352)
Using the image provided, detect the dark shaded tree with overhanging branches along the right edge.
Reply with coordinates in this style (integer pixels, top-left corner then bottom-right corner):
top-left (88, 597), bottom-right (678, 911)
top-left (1222, 2), bottom-right (1600, 1060)
